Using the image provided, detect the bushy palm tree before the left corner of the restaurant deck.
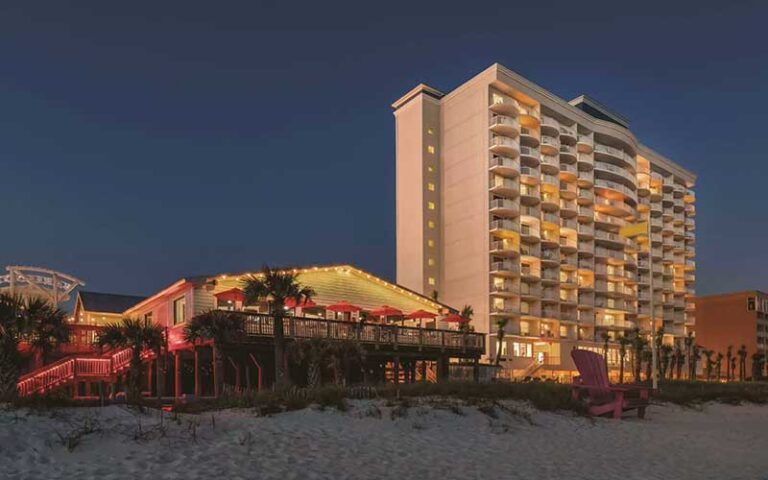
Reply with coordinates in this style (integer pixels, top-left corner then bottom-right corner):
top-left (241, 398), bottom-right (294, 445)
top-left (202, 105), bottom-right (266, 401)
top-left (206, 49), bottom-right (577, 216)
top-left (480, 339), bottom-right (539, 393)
top-left (184, 310), bottom-right (245, 397)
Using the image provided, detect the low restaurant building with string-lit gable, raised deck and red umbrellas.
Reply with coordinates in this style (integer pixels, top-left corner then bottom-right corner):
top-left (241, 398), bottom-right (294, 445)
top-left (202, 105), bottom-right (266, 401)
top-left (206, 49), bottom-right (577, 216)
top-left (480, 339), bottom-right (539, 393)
top-left (19, 265), bottom-right (485, 398)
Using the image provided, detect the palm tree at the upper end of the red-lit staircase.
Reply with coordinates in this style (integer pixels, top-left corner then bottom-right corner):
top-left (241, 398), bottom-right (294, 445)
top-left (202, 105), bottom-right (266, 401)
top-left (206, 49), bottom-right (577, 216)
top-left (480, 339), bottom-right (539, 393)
top-left (98, 318), bottom-right (165, 403)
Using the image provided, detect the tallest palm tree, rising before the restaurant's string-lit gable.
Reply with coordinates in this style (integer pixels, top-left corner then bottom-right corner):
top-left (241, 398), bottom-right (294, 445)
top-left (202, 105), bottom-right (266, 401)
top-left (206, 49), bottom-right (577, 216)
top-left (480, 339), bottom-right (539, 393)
top-left (243, 265), bottom-right (315, 388)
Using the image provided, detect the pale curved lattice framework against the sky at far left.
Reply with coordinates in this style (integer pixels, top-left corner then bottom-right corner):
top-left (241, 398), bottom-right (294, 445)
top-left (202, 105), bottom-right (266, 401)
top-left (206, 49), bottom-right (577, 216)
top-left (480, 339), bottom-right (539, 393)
top-left (0, 265), bottom-right (85, 305)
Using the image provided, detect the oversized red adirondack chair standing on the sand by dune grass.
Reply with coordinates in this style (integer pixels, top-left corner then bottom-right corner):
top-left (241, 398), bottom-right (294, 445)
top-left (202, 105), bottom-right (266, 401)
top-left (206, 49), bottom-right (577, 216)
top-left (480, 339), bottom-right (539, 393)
top-left (571, 349), bottom-right (648, 418)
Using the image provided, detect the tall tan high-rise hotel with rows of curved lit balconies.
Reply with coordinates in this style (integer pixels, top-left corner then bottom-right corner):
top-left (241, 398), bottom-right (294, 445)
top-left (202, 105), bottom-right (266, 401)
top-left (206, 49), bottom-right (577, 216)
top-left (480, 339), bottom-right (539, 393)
top-left (393, 64), bottom-right (696, 375)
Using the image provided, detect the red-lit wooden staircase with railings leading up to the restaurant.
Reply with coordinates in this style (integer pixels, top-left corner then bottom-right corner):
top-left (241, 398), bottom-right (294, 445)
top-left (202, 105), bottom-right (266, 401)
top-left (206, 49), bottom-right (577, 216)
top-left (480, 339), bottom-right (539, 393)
top-left (17, 348), bottom-right (154, 397)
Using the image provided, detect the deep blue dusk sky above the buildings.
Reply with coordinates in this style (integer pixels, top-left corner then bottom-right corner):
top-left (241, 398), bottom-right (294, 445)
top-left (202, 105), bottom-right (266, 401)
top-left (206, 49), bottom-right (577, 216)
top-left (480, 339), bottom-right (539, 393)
top-left (0, 1), bottom-right (768, 294)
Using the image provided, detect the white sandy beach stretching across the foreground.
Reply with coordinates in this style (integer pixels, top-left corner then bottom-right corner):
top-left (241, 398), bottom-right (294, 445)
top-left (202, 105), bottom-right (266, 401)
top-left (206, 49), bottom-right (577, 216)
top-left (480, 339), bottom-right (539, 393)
top-left (0, 401), bottom-right (768, 480)
